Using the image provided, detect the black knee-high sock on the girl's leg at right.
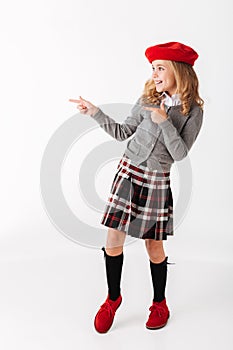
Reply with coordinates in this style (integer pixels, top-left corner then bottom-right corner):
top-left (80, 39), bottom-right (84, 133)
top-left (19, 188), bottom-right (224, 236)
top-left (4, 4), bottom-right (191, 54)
top-left (150, 257), bottom-right (168, 302)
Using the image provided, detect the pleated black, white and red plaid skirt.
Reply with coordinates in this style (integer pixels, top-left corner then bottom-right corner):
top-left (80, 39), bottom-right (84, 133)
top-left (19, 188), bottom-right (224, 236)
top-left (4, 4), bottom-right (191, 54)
top-left (101, 154), bottom-right (173, 240)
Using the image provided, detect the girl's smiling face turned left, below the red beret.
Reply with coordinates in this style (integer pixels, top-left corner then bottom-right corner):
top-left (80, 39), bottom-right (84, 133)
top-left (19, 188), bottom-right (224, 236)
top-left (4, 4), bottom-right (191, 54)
top-left (152, 60), bottom-right (176, 96)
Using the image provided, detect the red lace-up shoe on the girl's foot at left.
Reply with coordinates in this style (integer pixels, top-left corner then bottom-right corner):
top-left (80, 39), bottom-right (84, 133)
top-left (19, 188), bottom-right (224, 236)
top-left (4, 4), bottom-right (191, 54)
top-left (94, 294), bottom-right (122, 333)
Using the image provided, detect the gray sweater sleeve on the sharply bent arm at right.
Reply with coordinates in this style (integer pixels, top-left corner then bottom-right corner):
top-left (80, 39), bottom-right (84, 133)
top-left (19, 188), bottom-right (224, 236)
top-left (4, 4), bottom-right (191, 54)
top-left (159, 107), bottom-right (203, 161)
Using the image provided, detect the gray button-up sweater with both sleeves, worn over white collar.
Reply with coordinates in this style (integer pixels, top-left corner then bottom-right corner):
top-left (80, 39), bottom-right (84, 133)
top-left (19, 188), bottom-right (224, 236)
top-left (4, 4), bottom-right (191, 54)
top-left (92, 99), bottom-right (203, 172)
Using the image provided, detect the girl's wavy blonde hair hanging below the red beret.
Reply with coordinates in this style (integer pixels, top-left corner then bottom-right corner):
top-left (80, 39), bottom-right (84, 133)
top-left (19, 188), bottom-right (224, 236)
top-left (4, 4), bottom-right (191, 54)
top-left (141, 61), bottom-right (204, 115)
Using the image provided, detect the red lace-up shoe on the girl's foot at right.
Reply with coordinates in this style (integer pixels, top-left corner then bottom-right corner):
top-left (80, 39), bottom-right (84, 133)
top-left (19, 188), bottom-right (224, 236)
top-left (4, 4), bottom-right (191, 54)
top-left (146, 298), bottom-right (170, 329)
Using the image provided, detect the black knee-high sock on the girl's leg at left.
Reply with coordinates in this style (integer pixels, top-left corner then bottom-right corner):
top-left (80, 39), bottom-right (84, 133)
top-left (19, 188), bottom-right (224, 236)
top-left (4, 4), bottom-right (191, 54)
top-left (102, 247), bottom-right (124, 300)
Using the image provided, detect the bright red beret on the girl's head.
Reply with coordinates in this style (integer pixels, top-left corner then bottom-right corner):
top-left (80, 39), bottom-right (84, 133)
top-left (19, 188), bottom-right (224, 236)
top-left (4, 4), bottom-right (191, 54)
top-left (145, 41), bottom-right (198, 66)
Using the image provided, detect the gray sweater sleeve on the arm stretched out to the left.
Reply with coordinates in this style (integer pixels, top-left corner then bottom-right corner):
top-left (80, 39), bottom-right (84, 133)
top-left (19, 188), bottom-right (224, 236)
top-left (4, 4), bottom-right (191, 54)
top-left (91, 98), bottom-right (143, 141)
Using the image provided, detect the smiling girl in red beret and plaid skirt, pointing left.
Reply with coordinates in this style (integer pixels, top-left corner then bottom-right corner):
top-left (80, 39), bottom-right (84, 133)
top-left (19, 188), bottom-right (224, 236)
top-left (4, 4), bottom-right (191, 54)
top-left (70, 42), bottom-right (203, 333)
